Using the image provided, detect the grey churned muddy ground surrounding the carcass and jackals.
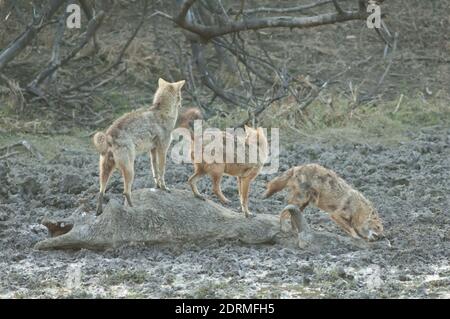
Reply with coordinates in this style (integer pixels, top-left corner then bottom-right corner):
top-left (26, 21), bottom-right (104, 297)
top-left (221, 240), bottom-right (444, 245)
top-left (0, 127), bottom-right (450, 298)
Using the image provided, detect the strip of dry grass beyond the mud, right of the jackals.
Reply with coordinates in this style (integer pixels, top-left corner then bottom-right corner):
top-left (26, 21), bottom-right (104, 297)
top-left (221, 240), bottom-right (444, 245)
top-left (262, 93), bottom-right (450, 143)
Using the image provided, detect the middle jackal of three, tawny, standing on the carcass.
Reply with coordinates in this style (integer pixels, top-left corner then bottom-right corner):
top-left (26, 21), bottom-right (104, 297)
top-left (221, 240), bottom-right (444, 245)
top-left (188, 126), bottom-right (268, 217)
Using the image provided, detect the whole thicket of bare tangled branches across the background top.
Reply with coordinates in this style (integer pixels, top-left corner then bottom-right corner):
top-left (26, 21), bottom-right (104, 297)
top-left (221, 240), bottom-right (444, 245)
top-left (0, 0), bottom-right (397, 125)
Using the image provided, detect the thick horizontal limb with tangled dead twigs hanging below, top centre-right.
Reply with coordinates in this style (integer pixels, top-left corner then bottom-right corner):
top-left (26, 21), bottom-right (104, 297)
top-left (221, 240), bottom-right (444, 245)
top-left (156, 0), bottom-right (386, 121)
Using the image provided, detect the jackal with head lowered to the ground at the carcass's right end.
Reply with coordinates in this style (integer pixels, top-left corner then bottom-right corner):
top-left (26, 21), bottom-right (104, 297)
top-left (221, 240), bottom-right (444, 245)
top-left (264, 164), bottom-right (384, 241)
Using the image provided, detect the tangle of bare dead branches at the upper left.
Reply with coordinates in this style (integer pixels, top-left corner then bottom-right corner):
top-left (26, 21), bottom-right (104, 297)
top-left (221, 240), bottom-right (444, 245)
top-left (0, 0), bottom-right (148, 125)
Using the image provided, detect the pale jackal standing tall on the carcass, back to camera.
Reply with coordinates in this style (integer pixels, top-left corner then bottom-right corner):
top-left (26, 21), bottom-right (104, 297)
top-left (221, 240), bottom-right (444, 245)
top-left (93, 78), bottom-right (185, 215)
